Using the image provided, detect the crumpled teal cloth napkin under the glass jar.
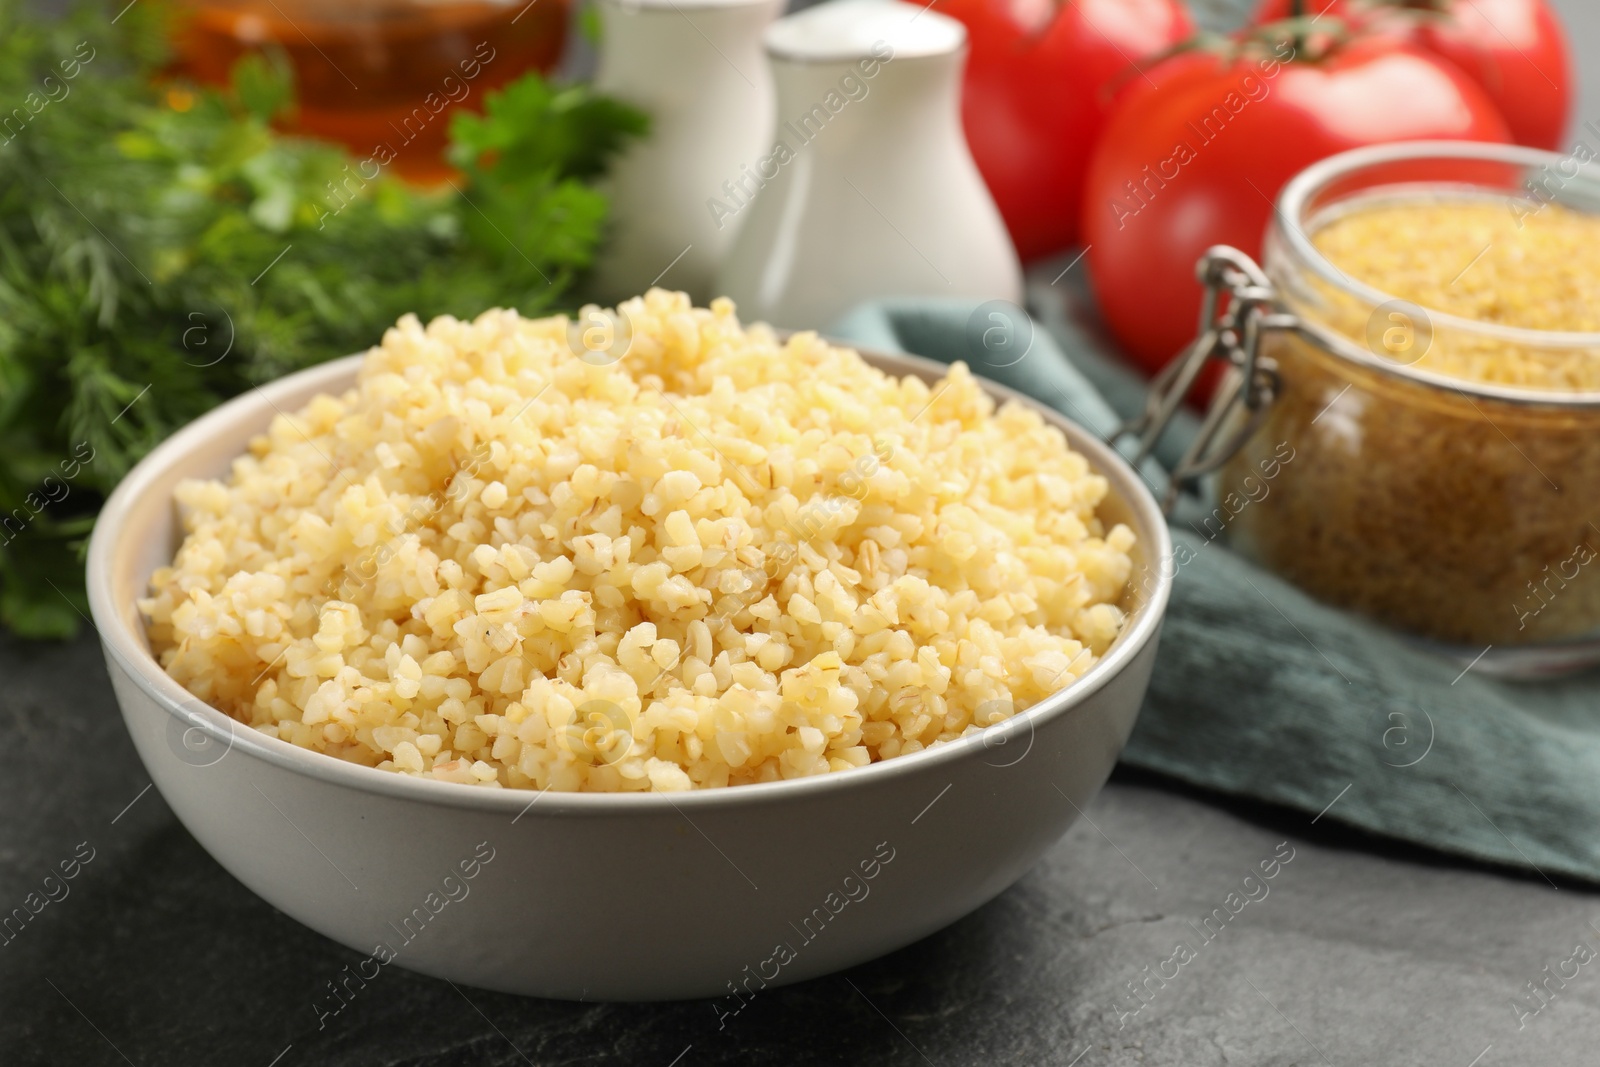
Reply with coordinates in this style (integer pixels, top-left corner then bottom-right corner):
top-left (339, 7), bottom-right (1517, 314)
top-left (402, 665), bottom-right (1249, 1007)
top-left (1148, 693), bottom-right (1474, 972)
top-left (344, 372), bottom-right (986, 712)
top-left (829, 283), bottom-right (1600, 885)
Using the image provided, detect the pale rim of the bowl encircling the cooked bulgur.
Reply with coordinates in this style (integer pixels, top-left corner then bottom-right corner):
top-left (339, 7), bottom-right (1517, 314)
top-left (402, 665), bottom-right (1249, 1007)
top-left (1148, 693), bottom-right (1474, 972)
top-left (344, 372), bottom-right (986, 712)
top-left (86, 341), bottom-right (1174, 812)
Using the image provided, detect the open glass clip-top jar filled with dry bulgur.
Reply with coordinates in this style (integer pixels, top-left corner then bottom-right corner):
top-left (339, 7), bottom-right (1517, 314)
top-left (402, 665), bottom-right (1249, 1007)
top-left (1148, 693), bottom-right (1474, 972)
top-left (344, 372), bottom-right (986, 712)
top-left (1139, 142), bottom-right (1600, 677)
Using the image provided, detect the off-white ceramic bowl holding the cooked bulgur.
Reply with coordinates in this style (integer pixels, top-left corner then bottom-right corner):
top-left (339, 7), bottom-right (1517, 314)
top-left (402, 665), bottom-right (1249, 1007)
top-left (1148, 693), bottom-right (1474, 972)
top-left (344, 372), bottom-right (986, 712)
top-left (88, 343), bottom-right (1171, 1011)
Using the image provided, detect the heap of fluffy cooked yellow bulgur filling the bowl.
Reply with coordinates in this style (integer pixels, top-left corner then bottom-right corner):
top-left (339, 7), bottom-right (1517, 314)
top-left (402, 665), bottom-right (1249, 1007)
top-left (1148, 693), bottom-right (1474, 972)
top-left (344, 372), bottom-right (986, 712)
top-left (139, 290), bottom-right (1134, 792)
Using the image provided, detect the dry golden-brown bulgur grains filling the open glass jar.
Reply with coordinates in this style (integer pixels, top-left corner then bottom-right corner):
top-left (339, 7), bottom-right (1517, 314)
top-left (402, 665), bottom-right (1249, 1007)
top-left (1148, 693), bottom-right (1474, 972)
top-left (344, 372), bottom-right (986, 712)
top-left (1219, 190), bottom-right (1600, 653)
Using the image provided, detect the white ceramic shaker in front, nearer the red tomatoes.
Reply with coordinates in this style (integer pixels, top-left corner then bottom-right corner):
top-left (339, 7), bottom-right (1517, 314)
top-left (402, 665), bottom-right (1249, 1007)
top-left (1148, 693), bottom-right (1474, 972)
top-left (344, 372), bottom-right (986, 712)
top-left (710, 0), bottom-right (1022, 330)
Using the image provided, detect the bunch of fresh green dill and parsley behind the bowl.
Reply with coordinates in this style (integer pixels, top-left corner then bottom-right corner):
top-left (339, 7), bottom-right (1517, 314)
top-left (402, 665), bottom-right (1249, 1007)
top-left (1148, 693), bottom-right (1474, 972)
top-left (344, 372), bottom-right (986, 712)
top-left (0, 0), bottom-right (646, 637)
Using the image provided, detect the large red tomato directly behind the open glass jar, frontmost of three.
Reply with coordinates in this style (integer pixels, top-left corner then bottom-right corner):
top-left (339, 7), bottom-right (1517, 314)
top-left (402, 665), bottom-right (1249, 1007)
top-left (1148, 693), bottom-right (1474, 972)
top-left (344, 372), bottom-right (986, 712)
top-left (1083, 37), bottom-right (1509, 371)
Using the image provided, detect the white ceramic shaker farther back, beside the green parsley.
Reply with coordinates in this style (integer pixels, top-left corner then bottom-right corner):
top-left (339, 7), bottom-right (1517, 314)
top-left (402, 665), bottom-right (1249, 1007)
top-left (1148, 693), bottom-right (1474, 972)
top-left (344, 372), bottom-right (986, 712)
top-left (595, 0), bottom-right (782, 302)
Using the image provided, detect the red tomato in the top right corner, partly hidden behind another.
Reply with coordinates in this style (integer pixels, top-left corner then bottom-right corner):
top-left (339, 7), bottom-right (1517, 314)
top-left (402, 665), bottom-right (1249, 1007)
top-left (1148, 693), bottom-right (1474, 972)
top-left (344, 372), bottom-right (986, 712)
top-left (1256, 0), bottom-right (1573, 149)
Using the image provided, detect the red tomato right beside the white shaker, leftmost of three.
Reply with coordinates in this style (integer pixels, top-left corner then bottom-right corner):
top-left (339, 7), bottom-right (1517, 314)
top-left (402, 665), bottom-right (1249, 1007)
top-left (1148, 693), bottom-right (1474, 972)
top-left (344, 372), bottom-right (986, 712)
top-left (939, 0), bottom-right (1194, 259)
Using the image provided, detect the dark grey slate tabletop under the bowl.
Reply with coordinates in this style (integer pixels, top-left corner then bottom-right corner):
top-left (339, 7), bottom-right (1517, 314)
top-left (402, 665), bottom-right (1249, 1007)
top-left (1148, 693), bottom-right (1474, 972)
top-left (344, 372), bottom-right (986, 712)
top-left (0, 638), bottom-right (1600, 1067)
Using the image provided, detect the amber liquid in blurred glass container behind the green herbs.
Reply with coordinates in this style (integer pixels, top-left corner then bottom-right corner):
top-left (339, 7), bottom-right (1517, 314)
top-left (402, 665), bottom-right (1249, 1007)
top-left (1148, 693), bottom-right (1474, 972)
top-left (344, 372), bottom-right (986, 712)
top-left (178, 0), bottom-right (568, 182)
